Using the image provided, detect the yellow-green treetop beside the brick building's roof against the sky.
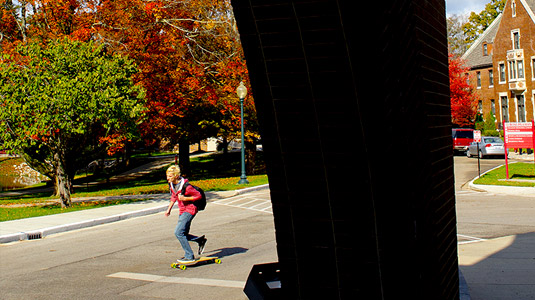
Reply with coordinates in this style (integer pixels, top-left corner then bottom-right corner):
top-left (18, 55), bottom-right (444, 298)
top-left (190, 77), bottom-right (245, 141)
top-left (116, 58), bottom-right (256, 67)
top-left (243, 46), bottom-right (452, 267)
top-left (463, 0), bottom-right (506, 46)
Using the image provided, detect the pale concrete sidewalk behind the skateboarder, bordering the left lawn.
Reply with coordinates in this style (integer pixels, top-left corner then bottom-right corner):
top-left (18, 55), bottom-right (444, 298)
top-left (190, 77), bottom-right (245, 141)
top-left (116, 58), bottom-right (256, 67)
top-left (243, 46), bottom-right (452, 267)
top-left (0, 184), bottom-right (269, 244)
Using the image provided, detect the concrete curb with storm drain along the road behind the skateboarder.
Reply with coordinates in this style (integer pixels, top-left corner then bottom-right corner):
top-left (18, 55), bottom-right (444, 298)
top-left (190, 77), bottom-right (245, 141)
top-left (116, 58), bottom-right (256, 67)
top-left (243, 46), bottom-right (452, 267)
top-left (0, 184), bottom-right (269, 244)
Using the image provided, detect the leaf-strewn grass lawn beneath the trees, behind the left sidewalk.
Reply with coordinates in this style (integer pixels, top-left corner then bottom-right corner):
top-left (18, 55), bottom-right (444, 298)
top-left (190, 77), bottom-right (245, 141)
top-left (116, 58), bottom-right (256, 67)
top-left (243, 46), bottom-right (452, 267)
top-left (0, 153), bottom-right (268, 222)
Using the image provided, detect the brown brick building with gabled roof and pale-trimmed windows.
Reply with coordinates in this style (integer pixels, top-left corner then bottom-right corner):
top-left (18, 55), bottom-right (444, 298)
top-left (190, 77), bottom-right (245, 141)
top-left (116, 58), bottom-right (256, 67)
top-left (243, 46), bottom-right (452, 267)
top-left (462, 0), bottom-right (535, 128)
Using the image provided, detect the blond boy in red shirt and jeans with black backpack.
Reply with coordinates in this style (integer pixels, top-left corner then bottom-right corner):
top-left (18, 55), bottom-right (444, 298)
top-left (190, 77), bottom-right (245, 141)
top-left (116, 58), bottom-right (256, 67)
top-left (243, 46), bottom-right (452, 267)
top-left (165, 165), bottom-right (206, 264)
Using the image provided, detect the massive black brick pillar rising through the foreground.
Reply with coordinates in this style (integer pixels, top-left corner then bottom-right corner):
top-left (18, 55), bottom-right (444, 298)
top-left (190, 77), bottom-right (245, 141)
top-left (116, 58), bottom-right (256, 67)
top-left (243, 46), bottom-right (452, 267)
top-left (232, 0), bottom-right (458, 300)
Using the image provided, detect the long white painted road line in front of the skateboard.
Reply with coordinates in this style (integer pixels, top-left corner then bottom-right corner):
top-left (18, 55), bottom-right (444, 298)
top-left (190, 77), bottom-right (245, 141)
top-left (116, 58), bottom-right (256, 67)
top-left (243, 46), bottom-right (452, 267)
top-left (106, 272), bottom-right (245, 289)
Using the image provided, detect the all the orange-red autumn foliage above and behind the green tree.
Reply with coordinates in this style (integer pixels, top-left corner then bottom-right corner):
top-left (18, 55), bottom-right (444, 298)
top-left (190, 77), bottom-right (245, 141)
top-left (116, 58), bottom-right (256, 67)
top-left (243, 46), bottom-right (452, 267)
top-left (0, 0), bottom-right (258, 205)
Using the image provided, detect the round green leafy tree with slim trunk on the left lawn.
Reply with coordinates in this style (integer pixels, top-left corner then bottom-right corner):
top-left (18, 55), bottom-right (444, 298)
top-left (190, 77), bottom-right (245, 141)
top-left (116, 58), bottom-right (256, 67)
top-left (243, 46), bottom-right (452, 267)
top-left (0, 39), bottom-right (144, 207)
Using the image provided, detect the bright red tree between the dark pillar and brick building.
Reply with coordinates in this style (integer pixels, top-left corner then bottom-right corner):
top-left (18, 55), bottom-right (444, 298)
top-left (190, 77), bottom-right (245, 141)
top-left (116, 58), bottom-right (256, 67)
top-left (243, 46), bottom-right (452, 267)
top-left (448, 54), bottom-right (477, 127)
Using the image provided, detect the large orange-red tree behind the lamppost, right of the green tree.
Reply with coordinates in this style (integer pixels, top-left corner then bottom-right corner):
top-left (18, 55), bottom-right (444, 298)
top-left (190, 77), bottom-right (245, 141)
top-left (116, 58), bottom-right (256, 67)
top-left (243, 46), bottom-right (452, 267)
top-left (91, 0), bottom-right (258, 174)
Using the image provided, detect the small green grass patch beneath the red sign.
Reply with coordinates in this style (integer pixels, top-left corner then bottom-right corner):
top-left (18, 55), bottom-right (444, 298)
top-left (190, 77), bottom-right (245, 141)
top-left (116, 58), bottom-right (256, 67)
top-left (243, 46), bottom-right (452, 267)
top-left (474, 162), bottom-right (535, 187)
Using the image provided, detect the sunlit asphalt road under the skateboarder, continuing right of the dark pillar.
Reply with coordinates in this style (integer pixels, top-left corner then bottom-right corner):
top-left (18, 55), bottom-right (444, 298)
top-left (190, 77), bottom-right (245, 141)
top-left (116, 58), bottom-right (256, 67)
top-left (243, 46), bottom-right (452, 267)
top-left (0, 157), bottom-right (535, 300)
